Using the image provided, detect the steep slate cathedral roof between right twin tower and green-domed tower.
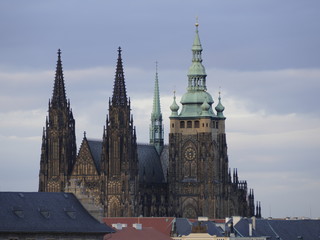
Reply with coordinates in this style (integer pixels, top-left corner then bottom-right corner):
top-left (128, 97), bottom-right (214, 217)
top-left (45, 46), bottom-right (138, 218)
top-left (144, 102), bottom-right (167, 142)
top-left (138, 144), bottom-right (164, 183)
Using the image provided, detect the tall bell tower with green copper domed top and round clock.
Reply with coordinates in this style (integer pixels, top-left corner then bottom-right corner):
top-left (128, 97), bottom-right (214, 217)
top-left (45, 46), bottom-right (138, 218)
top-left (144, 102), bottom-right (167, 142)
top-left (168, 23), bottom-right (228, 218)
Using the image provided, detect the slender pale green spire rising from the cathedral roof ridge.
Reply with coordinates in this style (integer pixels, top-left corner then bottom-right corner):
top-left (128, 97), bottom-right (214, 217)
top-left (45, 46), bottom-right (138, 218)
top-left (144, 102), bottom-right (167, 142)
top-left (150, 63), bottom-right (163, 155)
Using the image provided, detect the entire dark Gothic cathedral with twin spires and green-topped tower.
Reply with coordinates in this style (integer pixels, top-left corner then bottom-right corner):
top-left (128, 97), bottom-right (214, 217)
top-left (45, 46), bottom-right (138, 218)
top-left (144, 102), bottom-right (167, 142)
top-left (39, 24), bottom-right (261, 218)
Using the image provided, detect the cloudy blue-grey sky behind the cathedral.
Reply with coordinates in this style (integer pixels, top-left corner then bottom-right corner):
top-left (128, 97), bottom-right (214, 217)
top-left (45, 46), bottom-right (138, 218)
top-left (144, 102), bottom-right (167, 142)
top-left (0, 0), bottom-right (320, 218)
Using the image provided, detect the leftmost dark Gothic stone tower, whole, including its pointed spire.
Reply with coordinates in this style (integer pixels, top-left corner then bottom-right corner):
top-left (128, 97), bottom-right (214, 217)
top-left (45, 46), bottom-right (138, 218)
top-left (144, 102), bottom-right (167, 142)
top-left (39, 49), bottom-right (76, 192)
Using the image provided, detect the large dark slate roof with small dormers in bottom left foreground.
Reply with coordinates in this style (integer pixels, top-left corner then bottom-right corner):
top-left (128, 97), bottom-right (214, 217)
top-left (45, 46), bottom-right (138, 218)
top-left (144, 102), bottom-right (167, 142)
top-left (0, 192), bottom-right (115, 234)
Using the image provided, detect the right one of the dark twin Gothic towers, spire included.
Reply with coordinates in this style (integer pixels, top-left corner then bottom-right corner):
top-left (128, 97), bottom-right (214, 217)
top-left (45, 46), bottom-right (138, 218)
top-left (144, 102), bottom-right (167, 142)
top-left (101, 47), bottom-right (139, 217)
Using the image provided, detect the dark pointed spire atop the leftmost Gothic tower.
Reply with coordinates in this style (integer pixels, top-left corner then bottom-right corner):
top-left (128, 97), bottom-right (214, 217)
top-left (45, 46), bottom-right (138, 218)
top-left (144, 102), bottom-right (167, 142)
top-left (51, 49), bottom-right (67, 107)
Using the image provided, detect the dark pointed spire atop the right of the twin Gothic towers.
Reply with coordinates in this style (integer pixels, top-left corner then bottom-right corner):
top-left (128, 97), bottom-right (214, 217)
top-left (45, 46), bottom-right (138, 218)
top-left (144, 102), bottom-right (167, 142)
top-left (112, 47), bottom-right (127, 106)
